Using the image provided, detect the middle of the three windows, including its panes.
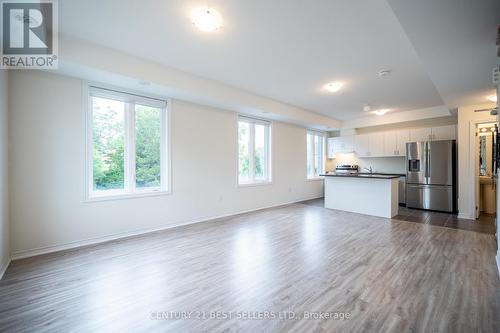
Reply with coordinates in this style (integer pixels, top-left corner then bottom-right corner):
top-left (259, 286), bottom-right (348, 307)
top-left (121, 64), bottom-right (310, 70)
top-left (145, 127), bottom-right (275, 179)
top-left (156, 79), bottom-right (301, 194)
top-left (238, 116), bottom-right (271, 184)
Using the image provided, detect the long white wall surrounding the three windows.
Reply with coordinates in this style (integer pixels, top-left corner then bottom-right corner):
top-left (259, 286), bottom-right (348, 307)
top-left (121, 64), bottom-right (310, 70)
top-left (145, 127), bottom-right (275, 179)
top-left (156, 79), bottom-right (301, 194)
top-left (9, 71), bottom-right (323, 257)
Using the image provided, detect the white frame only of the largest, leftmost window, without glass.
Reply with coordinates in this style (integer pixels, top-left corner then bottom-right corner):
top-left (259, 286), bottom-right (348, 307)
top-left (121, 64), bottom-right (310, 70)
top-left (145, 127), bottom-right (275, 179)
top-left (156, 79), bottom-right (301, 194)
top-left (83, 82), bottom-right (172, 202)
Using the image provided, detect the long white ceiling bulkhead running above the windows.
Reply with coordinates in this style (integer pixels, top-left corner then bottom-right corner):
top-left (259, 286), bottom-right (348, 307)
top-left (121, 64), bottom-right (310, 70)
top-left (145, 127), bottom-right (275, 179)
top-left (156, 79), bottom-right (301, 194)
top-left (58, 36), bottom-right (342, 130)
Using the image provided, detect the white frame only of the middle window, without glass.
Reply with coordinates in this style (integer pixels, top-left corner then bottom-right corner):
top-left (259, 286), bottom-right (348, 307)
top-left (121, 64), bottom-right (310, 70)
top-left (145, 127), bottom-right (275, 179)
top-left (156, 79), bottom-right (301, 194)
top-left (236, 114), bottom-right (273, 187)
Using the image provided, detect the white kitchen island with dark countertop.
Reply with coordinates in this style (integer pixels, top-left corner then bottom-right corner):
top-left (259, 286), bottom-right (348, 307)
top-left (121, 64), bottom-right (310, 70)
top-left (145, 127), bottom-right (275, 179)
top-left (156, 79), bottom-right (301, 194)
top-left (321, 173), bottom-right (399, 218)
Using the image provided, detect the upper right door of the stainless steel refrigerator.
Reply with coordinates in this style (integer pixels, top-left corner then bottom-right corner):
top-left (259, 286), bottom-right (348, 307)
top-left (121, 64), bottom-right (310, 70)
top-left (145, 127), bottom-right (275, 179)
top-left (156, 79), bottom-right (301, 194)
top-left (427, 140), bottom-right (453, 185)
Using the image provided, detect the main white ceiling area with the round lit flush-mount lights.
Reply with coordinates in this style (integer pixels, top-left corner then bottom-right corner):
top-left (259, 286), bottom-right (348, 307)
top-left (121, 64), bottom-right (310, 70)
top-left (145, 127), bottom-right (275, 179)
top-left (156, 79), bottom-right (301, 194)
top-left (59, 0), bottom-right (494, 120)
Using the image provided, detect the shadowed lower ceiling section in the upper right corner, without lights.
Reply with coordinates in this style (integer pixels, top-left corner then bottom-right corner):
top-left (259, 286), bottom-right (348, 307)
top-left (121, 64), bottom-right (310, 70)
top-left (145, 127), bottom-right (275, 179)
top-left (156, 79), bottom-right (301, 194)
top-left (388, 0), bottom-right (500, 108)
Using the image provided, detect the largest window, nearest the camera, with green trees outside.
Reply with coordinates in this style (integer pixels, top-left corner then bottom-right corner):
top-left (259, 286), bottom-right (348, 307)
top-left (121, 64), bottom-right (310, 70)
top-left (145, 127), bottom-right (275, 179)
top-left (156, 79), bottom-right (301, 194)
top-left (87, 87), bottom-right (168, 198)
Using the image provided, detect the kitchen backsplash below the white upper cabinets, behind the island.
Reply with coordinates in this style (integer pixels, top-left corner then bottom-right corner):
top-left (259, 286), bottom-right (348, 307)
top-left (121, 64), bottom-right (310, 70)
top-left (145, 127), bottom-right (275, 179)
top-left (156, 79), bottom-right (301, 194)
top-left (326, 153), bottom-right (406, 173)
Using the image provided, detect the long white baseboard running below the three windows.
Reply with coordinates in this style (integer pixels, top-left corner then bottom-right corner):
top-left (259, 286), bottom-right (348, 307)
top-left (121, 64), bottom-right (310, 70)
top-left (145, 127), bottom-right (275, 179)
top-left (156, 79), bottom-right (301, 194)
top-left (12, 195), bottom-right (323, 260)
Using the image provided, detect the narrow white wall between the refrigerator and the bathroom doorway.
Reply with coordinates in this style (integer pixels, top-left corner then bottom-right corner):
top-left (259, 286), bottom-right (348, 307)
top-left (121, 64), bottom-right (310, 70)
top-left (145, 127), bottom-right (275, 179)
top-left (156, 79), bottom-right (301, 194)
top-left (457, 103), bottom-right (496, 219)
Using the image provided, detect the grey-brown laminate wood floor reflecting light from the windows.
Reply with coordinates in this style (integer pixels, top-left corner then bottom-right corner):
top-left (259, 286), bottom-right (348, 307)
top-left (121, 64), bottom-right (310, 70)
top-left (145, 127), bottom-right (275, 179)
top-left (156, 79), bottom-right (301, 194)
top-left (0, 204), bottom-right (500, 332)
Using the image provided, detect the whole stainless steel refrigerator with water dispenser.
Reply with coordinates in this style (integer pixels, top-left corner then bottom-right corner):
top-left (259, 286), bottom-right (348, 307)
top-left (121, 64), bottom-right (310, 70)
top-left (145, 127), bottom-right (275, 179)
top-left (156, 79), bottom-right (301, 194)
top-left (406, 140), bottom-right (457, 212)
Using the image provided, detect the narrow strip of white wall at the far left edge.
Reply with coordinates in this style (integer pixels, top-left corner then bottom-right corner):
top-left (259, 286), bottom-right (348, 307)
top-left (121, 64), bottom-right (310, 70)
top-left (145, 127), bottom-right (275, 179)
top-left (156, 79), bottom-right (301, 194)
top-left (0, 70), bottom-right (10, 279)
